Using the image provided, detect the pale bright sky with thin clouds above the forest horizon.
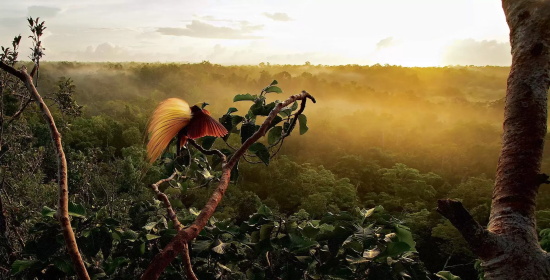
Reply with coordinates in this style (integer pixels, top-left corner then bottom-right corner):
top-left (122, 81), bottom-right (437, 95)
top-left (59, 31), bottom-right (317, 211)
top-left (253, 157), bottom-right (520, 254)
top-left (0, 0), bottom-right (511, 67)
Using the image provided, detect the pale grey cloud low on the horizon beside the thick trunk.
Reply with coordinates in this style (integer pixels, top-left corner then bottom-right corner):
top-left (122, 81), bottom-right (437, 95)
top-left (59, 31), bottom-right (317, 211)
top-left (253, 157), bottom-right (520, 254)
top-left (442, 39), bottom-right (512, 66)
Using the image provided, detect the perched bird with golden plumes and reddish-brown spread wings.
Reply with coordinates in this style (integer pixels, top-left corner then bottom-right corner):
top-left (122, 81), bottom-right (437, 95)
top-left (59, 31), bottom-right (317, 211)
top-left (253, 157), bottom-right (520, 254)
top-left (147, 98), bottom-right (227, 163)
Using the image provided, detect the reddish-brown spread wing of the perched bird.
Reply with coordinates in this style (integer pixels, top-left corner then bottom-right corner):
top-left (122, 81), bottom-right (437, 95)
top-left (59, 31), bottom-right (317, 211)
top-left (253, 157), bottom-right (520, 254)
top-left (186, 110), bottom-right (227, 139)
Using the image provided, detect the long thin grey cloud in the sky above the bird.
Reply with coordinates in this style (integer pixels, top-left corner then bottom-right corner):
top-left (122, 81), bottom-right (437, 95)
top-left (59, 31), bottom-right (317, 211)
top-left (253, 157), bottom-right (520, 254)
top-left (157, 20), bottom-right (263, 39)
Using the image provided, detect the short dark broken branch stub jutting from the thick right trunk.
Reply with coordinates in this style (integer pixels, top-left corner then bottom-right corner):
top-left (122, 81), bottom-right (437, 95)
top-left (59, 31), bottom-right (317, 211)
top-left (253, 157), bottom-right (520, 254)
top-left (436, 199), bottom-right (496, 258)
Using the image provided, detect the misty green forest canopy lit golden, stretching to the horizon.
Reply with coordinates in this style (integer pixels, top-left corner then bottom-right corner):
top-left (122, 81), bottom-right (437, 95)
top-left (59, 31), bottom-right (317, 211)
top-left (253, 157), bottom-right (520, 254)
top-left (0, 61), bottom-right (550, 279)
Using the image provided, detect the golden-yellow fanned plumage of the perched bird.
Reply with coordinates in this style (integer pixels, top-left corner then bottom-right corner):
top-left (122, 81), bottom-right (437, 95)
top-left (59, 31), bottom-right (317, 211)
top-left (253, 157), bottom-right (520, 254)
top-left (147, 98), bottom-right (191, 163)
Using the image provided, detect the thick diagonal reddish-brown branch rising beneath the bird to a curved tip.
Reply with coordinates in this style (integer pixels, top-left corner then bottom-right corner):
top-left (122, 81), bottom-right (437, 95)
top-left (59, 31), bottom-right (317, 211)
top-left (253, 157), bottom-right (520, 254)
top-left (141, 91), bottom-right (315, 280)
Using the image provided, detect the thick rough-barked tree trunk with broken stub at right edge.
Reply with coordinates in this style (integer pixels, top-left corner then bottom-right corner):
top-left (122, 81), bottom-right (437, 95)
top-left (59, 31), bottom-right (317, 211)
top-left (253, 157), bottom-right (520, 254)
top-left (438, 0), bottom-right (550, 280)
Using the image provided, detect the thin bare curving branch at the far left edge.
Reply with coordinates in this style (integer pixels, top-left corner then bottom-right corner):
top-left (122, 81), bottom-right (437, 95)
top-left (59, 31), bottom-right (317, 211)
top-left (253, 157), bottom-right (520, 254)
top-left (0, 61), bottom-right (90, 280)
